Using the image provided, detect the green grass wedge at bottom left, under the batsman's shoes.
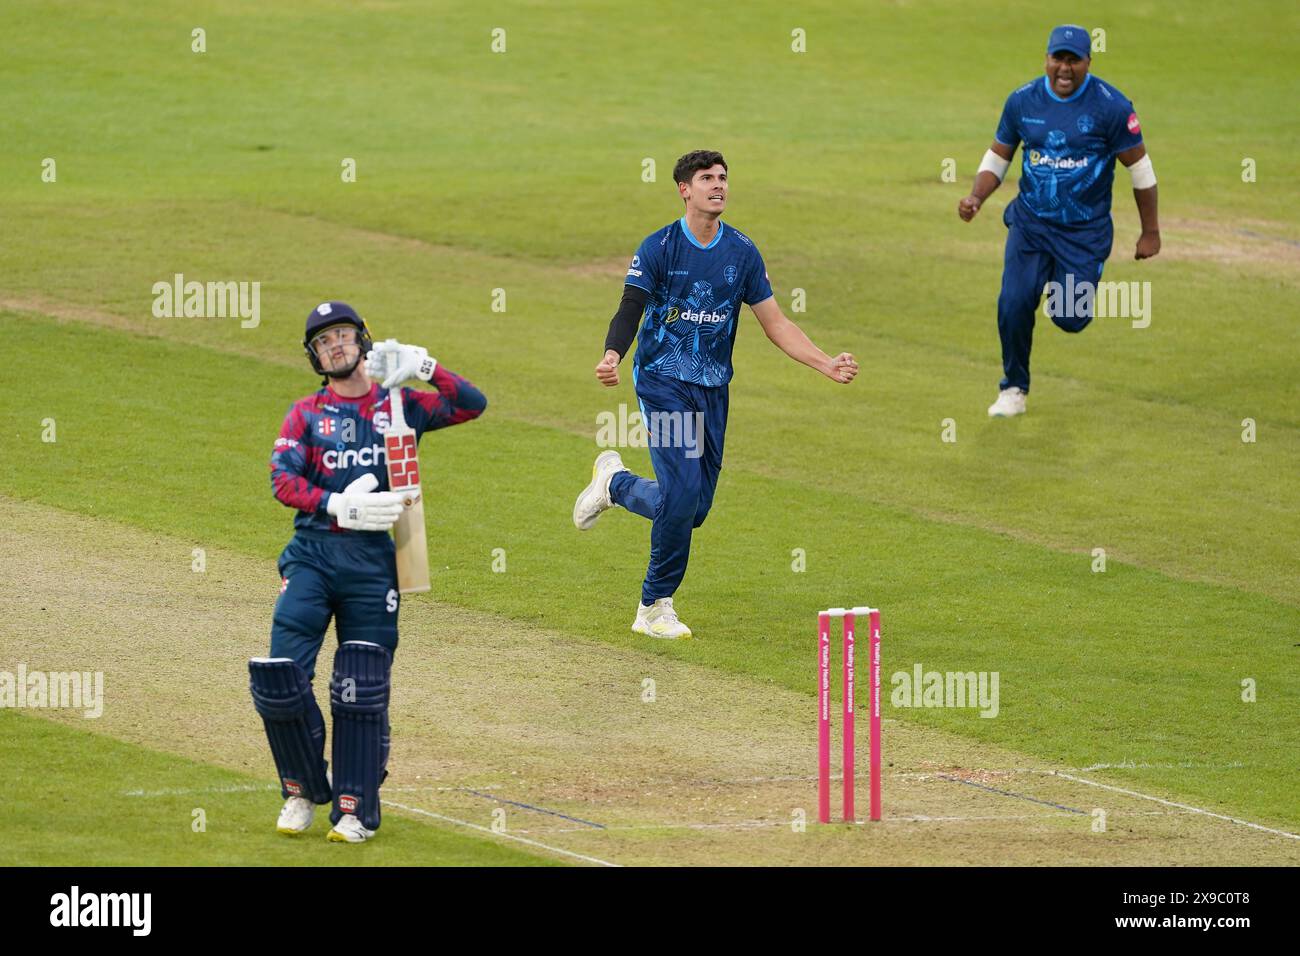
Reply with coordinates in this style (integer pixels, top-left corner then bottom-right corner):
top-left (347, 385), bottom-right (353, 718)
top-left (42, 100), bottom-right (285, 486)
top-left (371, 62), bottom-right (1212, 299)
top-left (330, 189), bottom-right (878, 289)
top-left (0, 711), bottom-right (551, 866)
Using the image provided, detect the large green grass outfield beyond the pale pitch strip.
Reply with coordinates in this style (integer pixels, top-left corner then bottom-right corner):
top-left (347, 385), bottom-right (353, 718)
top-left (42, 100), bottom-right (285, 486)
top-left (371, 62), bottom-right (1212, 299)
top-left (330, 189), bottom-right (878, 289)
top-left (0, 3), bottom-right (1300, 862)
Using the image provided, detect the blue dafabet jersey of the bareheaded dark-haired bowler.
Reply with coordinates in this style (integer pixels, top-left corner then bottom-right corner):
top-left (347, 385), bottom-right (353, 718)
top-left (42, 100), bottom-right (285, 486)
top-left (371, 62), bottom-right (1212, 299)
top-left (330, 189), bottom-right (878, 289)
top-left (624, 217), bottom-right (772, 385)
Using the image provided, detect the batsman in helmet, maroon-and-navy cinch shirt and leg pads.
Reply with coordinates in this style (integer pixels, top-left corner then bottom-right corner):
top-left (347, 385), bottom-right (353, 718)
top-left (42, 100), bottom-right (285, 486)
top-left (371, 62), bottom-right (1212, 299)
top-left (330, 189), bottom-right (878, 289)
top-left (248, 302), bottom-right (488, 843)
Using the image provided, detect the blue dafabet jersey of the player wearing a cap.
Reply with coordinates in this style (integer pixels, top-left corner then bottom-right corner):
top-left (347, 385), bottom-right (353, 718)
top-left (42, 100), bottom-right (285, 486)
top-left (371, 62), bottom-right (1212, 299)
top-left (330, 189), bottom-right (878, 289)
top-left (995, 73), bottom-right (1141, 225)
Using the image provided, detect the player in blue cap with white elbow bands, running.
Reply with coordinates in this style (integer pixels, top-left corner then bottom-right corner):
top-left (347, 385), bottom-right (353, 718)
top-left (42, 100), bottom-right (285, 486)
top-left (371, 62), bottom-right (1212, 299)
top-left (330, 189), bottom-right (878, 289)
top-left (957, 25), bottom-right (1160, 418)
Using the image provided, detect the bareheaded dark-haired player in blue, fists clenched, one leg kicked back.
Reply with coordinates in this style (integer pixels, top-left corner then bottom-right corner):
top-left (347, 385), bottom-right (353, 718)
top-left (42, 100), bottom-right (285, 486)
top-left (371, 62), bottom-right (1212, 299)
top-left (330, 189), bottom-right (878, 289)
top-left (573, 150), bottom-right (858, 640)
